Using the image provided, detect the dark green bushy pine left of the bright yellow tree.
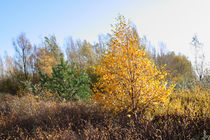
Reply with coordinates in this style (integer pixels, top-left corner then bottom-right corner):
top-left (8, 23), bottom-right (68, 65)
top-left (41, 59), bottom-right (90, 101)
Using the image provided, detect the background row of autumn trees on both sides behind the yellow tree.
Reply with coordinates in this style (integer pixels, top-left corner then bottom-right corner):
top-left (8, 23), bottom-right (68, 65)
top-left (0, 15), bottom-right (209, 98)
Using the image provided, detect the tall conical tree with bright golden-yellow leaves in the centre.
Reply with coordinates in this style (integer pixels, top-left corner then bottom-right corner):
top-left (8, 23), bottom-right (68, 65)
top-left (93, 16), bottom-right (174, 112)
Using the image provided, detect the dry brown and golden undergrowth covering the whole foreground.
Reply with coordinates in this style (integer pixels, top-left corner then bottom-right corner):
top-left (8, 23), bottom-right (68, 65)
top-left (0, 90), bottom-right (210, 140)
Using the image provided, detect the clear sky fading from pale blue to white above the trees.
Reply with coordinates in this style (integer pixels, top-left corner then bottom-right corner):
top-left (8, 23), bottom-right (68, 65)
top-left (0, 0), bottom-right (210, 65)
